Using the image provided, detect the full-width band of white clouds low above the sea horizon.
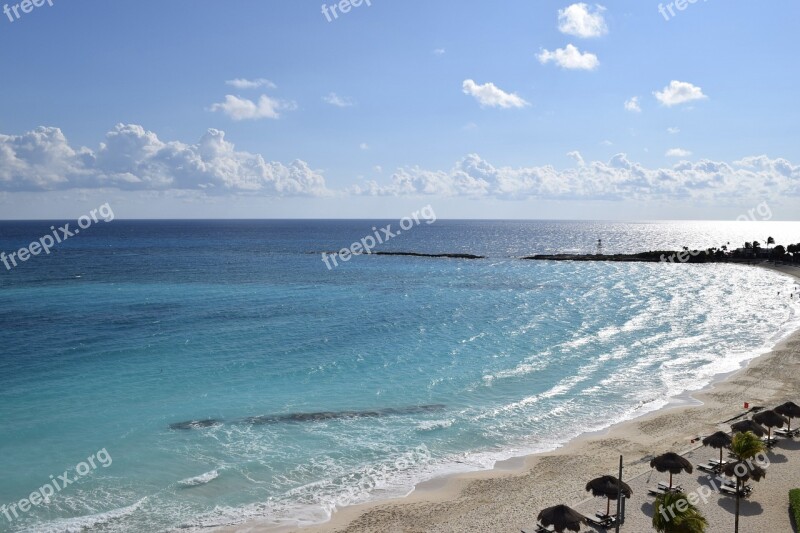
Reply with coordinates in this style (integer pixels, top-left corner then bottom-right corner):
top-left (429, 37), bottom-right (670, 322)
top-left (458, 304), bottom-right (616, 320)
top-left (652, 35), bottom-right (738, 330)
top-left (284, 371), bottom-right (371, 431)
top-left (0, 124), bottom-right (800, 201)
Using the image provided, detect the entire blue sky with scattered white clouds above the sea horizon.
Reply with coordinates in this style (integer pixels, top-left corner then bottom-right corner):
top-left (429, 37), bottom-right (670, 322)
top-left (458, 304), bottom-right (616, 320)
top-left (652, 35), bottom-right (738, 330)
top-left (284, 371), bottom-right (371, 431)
top-left (0, 0), bottom-right (800, 220)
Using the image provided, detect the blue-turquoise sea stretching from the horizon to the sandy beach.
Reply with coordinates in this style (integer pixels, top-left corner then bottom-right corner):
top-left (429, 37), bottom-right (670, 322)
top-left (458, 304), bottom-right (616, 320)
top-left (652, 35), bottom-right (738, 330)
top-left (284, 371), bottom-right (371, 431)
top-left (0, 221), bottom-right (800, 532)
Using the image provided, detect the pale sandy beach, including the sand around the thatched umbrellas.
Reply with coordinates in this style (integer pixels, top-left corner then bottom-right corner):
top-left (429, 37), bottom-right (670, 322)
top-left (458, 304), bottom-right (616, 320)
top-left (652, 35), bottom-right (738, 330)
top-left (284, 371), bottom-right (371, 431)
top-left (220, 265), bottom-right (800, 533)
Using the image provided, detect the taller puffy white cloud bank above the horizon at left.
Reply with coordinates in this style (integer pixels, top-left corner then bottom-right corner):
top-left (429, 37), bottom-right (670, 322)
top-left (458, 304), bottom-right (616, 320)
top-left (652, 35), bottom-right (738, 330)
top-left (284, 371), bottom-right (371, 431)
top-left (0, 124), bottom-right (331, 196)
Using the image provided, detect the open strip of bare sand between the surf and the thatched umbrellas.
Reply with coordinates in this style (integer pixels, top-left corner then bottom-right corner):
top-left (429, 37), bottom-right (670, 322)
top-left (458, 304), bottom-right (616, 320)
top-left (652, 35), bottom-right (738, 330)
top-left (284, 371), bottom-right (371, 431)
top-left (219, 263), bottom-right (800, 533)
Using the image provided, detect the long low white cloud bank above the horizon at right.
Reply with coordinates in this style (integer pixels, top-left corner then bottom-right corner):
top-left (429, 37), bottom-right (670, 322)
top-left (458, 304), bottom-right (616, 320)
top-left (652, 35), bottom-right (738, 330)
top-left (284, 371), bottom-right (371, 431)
top-left (351, 152), bottom-right (800, 201)
